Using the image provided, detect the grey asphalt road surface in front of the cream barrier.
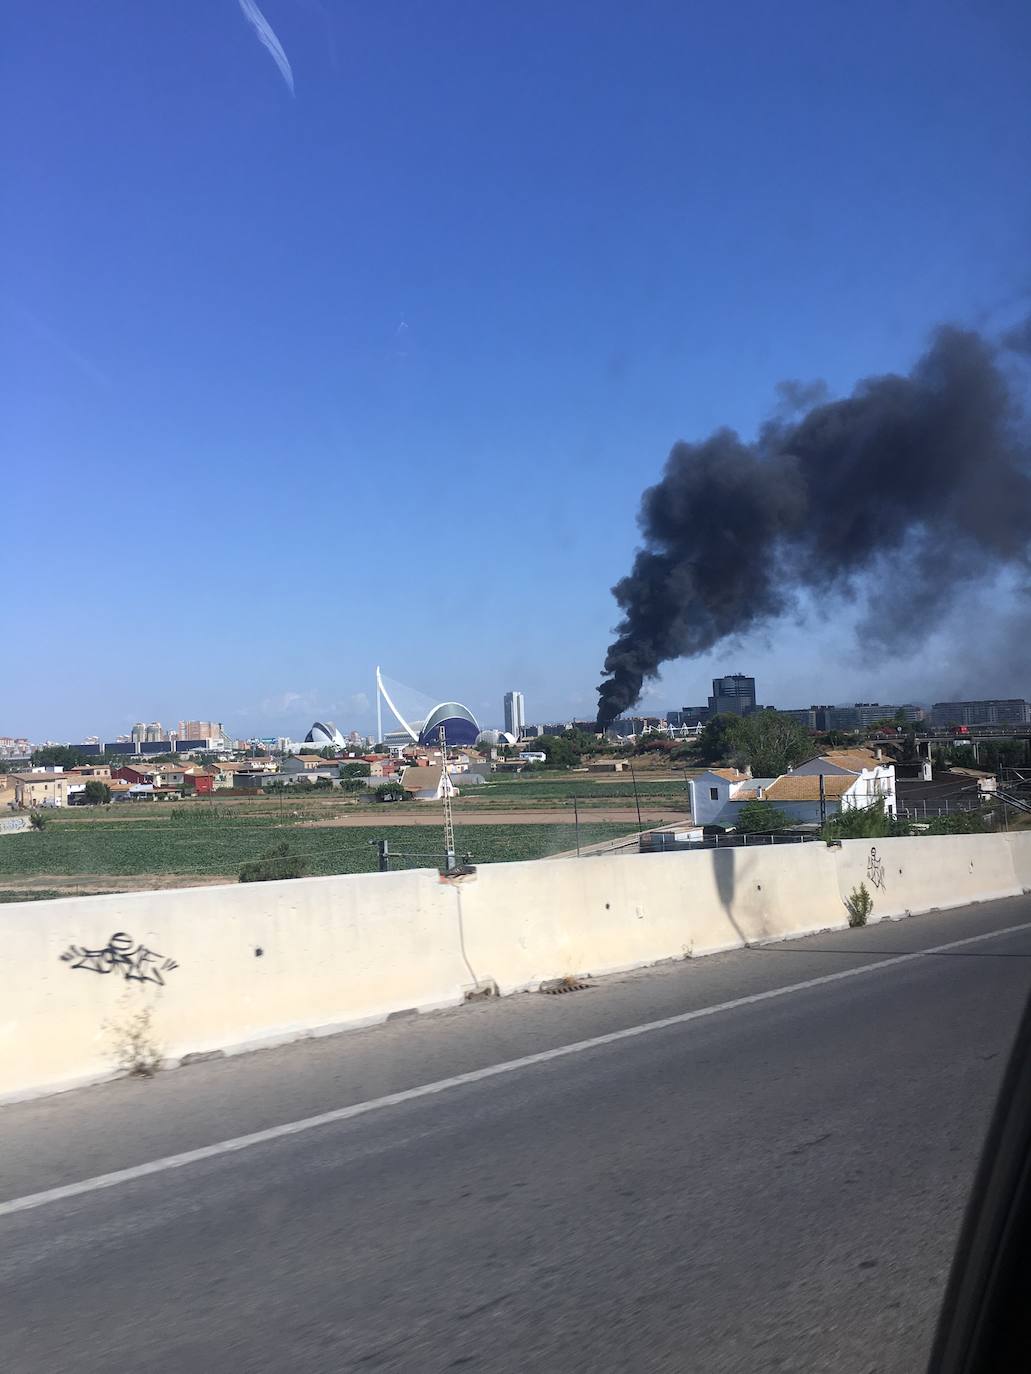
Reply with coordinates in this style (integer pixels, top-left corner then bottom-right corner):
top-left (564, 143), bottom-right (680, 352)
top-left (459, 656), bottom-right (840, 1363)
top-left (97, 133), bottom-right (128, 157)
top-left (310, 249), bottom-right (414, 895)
top-left (0, 899), bottom-right (1031, 1374)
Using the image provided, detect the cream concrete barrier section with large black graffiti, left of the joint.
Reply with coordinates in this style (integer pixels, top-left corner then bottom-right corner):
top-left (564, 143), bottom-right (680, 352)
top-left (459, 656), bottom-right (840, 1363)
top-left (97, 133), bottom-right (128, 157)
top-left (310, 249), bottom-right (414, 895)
top-left (0, 872), bottom-right (469, 1098)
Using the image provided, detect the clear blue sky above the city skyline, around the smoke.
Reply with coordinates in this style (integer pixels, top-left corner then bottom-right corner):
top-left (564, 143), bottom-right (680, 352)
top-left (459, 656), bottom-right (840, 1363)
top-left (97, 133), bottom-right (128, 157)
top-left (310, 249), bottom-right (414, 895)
top-left (0, 0), bottom-right (1031, 739)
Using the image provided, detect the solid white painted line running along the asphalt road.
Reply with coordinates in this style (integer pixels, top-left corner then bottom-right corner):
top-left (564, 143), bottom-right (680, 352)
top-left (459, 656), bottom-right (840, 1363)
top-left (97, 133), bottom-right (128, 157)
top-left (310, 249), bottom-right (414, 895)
top-left (0, 921), bottom-right (1031, 1216)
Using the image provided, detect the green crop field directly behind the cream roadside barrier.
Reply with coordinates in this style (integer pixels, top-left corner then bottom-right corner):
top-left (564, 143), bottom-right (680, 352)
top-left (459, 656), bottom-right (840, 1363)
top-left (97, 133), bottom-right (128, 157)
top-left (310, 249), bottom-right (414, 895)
top-left (0, 805), bottom-right (632, 892)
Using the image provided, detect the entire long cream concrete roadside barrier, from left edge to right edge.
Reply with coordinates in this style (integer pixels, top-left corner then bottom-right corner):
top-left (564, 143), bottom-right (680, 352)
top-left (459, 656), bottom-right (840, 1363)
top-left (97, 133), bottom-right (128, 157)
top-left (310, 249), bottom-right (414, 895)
top-left (0, 834), bottom-right (1031, 1099)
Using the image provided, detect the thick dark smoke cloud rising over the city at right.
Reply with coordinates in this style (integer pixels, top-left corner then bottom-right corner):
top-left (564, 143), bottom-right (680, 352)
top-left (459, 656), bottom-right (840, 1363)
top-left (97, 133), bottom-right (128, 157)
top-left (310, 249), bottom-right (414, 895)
top-left (598, 322), bottom-right (1031, 723)
